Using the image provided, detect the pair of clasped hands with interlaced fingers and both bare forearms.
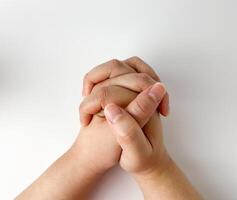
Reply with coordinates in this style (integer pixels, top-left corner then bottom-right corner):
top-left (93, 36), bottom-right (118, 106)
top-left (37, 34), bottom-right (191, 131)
top-left (16, 57), bottom-right (201, 200)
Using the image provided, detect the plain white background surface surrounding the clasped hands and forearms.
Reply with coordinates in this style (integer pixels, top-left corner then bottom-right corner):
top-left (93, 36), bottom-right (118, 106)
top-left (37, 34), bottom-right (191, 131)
top-left (0, 0), bottom-right (237, 200)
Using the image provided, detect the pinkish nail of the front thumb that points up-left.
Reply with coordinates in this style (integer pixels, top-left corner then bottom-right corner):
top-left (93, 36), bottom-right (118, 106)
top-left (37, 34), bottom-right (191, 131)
top-left (104, 104), bottom-right (122, 123)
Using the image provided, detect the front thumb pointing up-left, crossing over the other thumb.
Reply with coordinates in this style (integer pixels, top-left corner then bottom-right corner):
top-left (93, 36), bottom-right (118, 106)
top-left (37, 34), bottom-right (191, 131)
top-left (104, 104), bottom-right (152, 161)
